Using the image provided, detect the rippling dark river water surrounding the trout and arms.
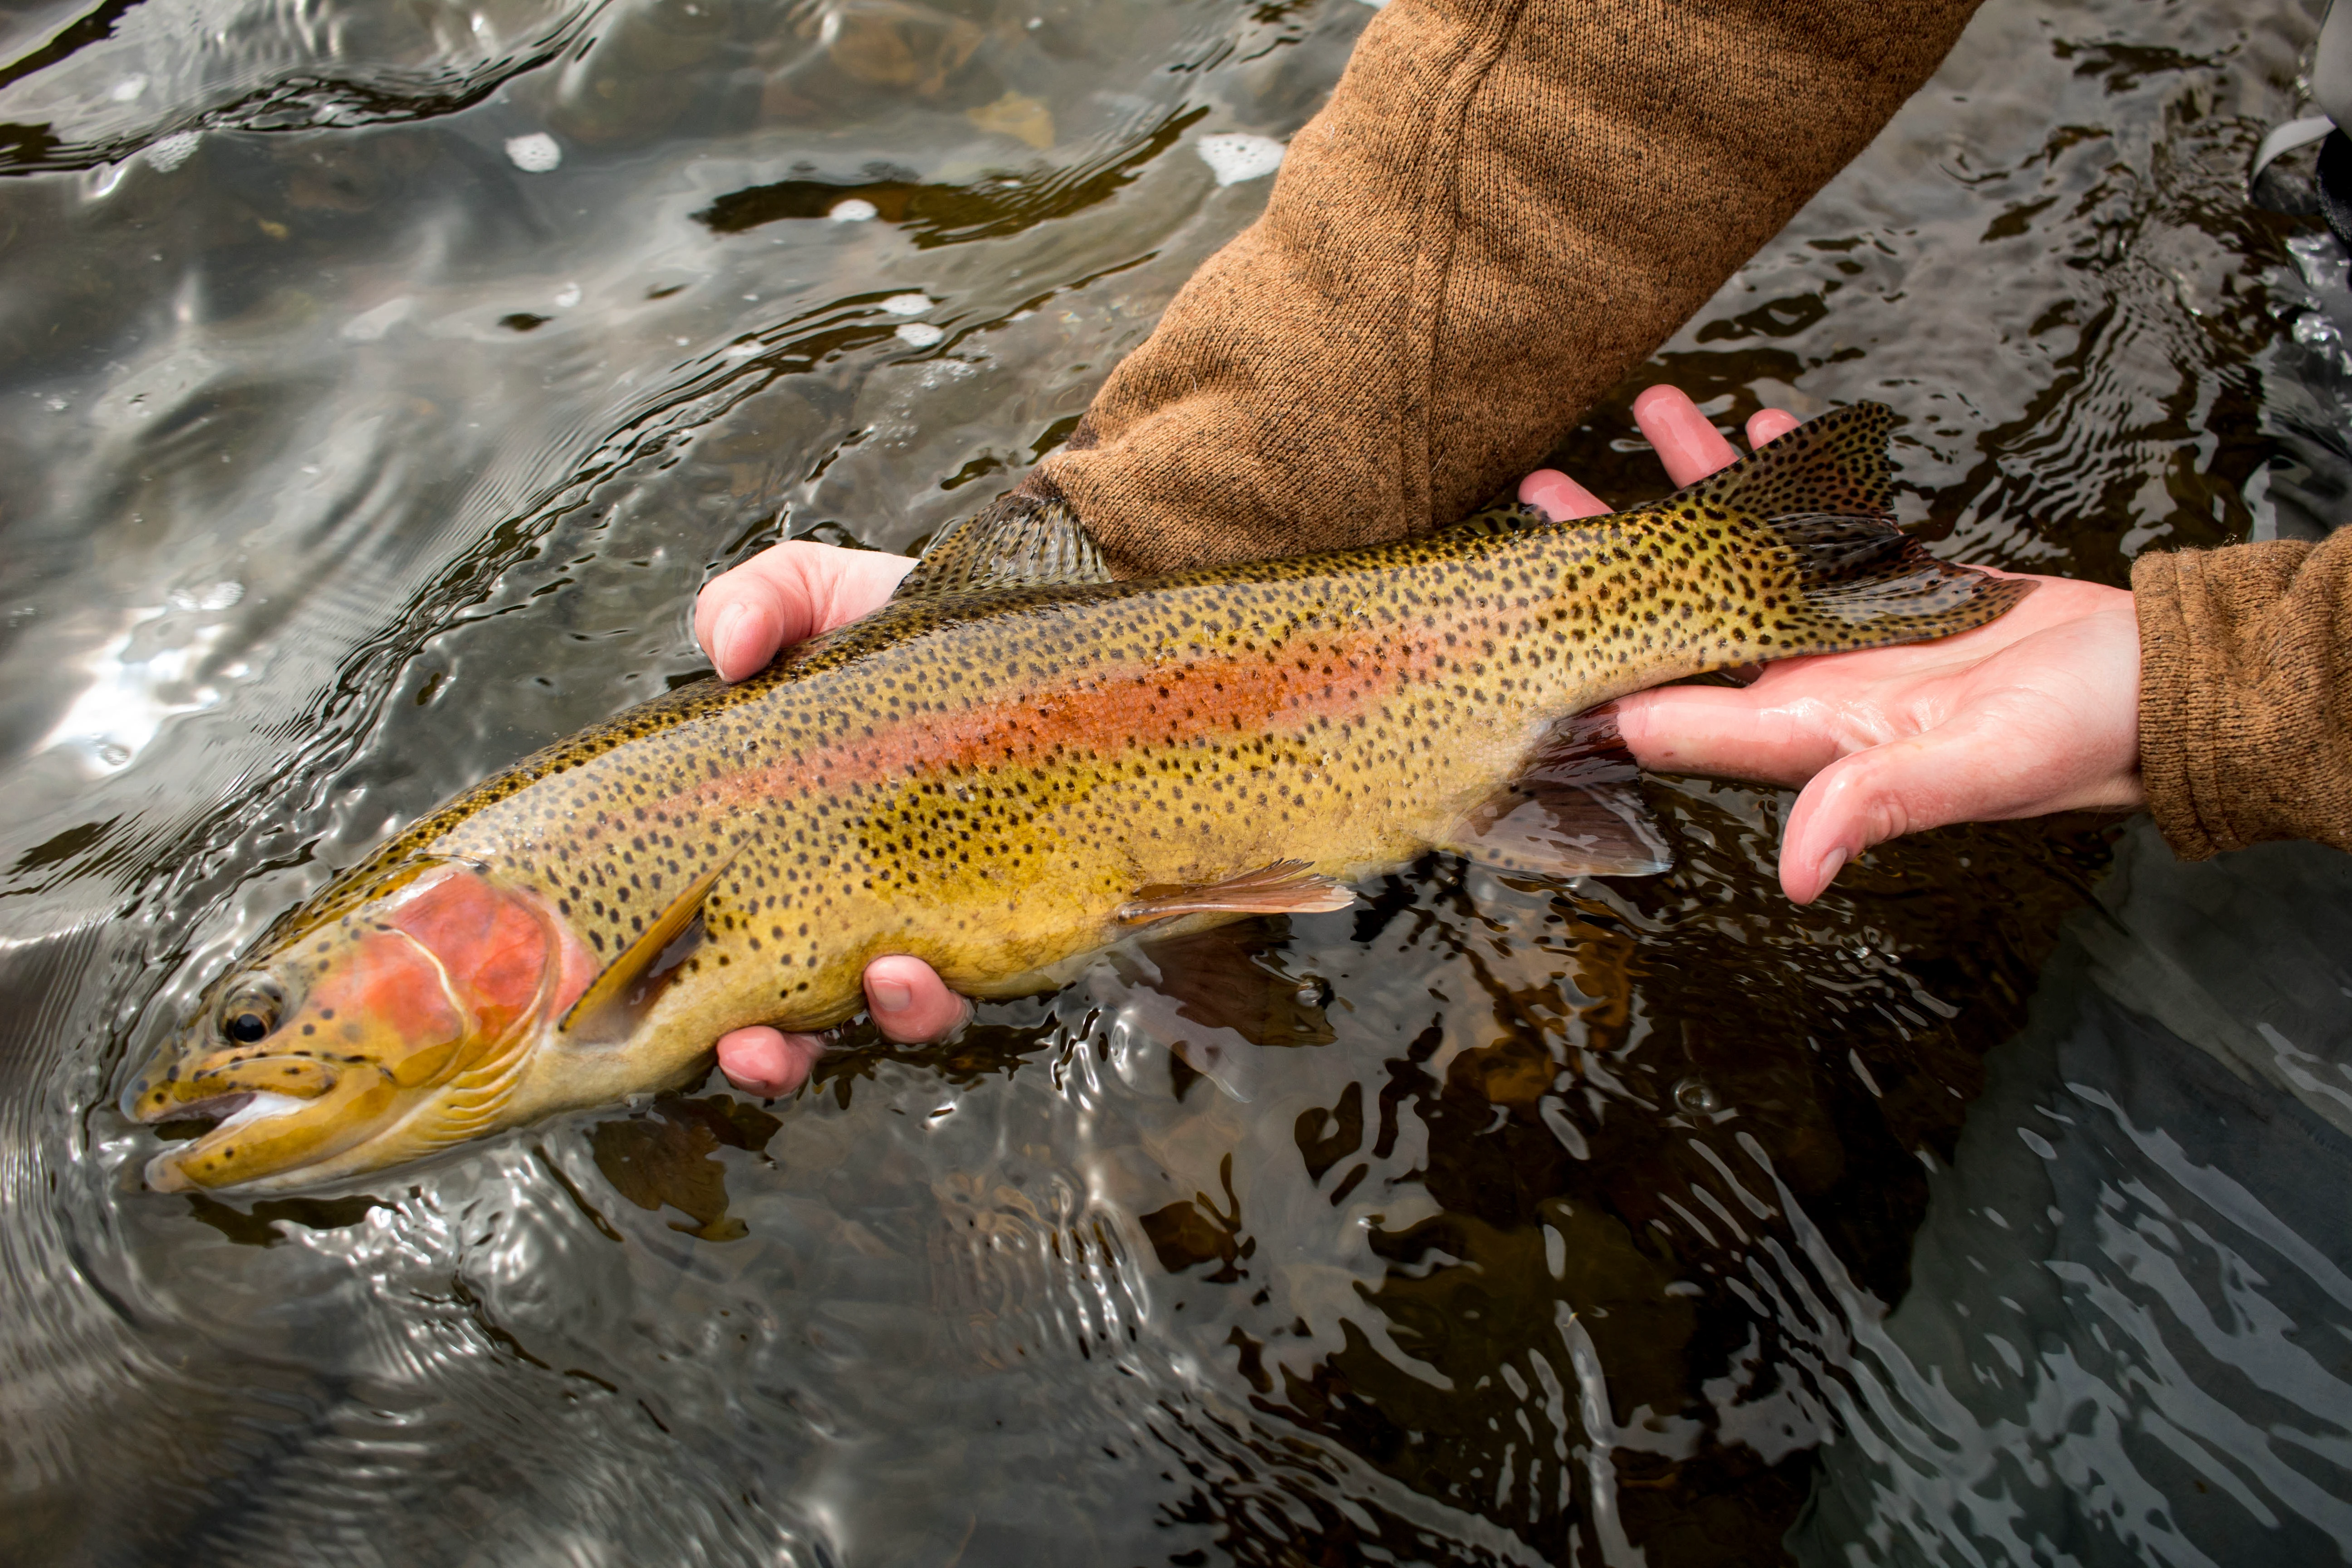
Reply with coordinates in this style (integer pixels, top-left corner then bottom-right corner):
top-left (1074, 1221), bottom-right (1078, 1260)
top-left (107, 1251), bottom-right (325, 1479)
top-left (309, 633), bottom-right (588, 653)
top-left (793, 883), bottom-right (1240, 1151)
top-left (0, 0), bottom-right (2352, 1563)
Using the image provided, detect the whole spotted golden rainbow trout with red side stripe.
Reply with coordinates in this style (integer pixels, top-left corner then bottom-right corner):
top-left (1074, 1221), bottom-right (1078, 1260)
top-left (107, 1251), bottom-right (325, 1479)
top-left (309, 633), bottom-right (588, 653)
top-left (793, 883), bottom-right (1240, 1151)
top-left (125, 404), bottom-right (2028, 1190)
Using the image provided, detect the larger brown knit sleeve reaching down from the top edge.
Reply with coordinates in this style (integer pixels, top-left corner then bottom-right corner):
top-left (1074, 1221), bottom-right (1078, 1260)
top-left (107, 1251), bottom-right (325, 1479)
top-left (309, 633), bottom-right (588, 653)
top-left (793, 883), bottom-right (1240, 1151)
top-left (988, 0), bottom-right (1976, 576)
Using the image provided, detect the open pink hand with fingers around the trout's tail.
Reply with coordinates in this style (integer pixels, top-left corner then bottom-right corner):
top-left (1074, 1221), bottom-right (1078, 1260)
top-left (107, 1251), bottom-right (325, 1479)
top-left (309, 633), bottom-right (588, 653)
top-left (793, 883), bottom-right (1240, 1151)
top-left (1519, 386), bottom-right (2145, 903)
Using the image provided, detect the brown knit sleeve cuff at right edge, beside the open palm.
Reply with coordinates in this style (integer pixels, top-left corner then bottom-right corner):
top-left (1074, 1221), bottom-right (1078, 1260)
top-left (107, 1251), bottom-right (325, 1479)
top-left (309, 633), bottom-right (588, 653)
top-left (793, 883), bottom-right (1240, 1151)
top-left (2131, 529), bottom-right (2352, 860)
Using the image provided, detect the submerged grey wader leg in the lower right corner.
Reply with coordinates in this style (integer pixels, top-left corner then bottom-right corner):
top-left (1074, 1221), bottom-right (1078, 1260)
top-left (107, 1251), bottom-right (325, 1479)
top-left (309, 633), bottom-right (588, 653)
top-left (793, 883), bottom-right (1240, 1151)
top-left (1808, 825), bottom-right (2352, 1563)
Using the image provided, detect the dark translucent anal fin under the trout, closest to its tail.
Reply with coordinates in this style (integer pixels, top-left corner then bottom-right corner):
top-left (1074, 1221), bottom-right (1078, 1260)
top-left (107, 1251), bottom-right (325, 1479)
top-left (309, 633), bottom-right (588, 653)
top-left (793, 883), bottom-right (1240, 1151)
top-left (1440, 708), bottom-right (1675, 877)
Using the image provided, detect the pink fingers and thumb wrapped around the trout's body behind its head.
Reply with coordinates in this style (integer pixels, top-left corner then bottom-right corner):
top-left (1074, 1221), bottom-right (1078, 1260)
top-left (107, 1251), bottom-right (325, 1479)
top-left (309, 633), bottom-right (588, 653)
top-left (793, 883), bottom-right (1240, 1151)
top-left (694, 539), bottom-right (969, 1096)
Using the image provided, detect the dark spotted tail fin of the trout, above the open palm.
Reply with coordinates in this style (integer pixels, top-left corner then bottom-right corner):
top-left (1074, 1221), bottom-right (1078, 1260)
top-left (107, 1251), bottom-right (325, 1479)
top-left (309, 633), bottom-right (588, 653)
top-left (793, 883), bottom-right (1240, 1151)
top-left (1637, 402), bottom-right (2034, 658)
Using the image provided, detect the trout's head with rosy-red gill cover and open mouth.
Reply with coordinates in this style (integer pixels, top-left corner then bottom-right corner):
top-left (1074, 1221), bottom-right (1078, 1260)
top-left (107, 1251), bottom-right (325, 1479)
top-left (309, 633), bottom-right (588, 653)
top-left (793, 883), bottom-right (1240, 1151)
top-left (122, 860), bottom-right (595, 1192)
